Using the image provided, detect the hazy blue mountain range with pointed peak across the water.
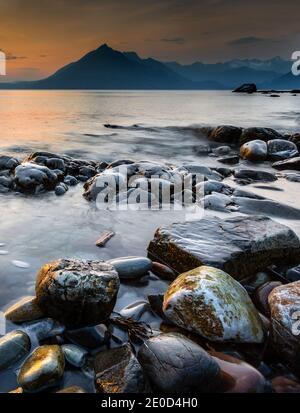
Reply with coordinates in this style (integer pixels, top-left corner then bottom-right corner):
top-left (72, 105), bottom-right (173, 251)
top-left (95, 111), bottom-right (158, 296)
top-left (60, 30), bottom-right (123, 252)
top-left (0, 44), bottom-right (300, 90)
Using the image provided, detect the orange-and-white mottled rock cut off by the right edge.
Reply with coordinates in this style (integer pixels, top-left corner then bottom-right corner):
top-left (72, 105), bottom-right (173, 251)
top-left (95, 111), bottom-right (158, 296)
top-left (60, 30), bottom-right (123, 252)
top-left (268, 281), bottom-right (300, 371)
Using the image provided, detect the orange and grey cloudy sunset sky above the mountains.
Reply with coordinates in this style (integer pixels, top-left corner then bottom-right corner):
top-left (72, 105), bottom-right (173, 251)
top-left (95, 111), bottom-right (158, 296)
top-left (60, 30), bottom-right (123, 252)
top-left (0, 0), bottom-right (300, 80)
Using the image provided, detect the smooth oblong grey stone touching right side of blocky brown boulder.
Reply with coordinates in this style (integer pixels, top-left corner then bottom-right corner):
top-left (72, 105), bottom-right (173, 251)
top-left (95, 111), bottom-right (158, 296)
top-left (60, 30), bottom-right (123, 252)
top-left (107, 257), bottom-right (152, 279)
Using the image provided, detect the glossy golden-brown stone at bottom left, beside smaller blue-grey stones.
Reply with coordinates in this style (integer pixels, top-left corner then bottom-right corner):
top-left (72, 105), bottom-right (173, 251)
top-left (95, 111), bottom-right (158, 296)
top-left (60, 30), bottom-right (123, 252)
top-left (18, 345), bottom-right (65, 393)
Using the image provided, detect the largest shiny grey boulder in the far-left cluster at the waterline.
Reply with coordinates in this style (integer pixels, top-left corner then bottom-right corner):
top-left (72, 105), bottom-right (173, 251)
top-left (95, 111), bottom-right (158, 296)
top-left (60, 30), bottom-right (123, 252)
top-left (15, 162), bottom-right (58, 193)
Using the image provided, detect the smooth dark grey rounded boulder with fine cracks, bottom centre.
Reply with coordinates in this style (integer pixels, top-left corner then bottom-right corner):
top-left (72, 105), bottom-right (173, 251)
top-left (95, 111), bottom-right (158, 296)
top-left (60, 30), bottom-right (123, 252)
top-left (138, 333), bottom-right (220, 394)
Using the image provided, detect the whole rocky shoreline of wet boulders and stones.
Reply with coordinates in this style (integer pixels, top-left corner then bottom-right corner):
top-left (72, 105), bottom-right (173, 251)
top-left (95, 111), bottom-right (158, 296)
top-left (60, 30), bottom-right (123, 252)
top-left (0, 125), bottom-right (300, 393)
